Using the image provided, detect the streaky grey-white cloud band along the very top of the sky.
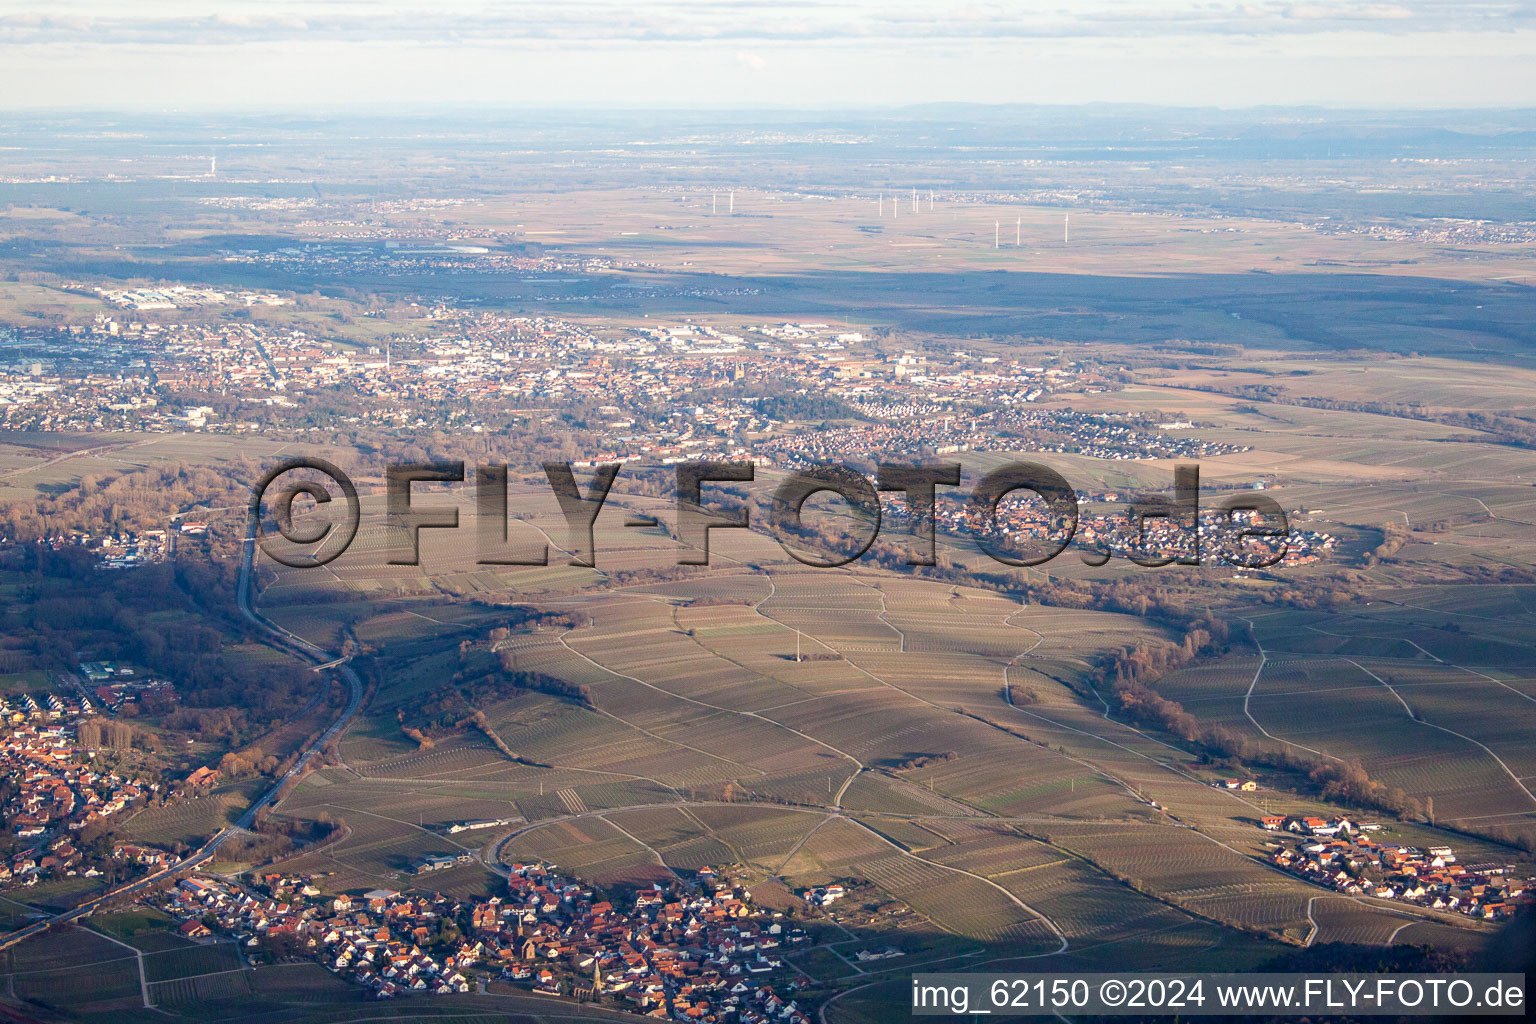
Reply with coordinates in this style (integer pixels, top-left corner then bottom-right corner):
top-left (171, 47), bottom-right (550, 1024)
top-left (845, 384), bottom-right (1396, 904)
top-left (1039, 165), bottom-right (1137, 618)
top-left (0, 0), bottom-right (1536, 49)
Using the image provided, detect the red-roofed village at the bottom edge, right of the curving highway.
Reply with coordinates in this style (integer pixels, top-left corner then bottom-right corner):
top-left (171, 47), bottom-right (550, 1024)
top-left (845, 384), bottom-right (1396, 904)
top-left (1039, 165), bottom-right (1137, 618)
top-left (146, 863), bottom-right (811, 1024)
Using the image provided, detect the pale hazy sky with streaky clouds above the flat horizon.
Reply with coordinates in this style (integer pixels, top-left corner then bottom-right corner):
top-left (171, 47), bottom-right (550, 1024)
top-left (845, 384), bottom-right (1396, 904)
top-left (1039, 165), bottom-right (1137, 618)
top-left (0, 0), bottom-right (1536, 112)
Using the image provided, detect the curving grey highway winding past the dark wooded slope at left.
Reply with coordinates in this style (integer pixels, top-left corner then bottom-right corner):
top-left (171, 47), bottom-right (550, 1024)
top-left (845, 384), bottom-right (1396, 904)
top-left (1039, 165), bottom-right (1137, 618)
top-left (0, 517), bottom-right (362, 949)
